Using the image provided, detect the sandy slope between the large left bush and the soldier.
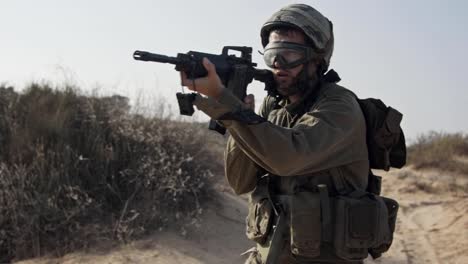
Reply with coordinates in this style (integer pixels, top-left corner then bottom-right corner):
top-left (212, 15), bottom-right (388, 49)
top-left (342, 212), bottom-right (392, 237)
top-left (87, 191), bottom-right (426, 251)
top-left (19, 188), bottom-right (254, 264)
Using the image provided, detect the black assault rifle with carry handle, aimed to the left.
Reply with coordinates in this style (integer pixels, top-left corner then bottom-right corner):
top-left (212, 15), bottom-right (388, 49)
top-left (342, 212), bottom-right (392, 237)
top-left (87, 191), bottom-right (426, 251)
top-left (133, 46), bottom-right (274, 134)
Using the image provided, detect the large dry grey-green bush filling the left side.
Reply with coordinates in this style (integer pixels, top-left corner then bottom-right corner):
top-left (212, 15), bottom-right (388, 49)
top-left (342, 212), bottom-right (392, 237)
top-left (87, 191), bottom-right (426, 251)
top-left (0, 84), bottom-right (218, 262)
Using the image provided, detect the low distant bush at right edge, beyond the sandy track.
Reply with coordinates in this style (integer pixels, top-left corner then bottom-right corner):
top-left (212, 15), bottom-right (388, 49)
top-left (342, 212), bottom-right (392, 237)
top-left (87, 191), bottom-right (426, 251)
top-left (408, 132), bottom-right (468, 175)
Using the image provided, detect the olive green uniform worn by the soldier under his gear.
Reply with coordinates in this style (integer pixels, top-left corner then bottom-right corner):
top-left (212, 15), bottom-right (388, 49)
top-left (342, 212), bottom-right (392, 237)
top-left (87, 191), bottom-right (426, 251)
top-left (195, 79), bottom-right (369, 263)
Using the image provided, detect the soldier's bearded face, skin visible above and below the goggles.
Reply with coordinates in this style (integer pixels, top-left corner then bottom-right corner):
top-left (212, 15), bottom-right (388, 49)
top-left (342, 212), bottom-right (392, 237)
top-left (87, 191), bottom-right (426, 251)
top-left (268, 31), bottom-right (312, 96)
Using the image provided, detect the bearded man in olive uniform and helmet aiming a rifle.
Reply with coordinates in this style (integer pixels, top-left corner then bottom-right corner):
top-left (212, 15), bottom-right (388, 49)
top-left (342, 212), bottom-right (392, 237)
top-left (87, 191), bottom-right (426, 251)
top-left (181, 4), bottom-right (369, 263)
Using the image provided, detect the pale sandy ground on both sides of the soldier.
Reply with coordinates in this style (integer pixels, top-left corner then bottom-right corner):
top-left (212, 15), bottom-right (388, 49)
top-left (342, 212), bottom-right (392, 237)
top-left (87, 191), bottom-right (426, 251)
top-left (16, 169), bottom-right (468, 264)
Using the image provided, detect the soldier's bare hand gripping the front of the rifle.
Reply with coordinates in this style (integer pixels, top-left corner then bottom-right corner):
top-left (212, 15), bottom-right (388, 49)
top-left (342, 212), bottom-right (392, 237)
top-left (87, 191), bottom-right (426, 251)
top-left (180, 58), bottom-right (225, 99)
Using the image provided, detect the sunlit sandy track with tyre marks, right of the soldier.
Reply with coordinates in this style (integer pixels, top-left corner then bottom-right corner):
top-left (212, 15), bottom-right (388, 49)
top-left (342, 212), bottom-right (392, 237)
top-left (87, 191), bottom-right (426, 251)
top-left (367, 169), bottom-right (468, 264)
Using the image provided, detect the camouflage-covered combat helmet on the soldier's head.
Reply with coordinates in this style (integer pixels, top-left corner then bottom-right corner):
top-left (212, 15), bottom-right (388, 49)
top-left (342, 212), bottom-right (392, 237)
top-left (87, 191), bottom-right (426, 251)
top-left (260, 4), bottom-right (334, 71)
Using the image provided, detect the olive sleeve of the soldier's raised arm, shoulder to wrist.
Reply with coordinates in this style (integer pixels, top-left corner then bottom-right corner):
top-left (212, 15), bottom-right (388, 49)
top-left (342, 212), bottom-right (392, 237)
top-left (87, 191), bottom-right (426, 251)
top-left (192, 85), bottom-right (367, 176)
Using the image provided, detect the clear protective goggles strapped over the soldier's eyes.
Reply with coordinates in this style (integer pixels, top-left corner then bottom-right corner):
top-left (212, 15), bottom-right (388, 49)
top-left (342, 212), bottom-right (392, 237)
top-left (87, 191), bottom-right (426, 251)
top-left (263, 42), bottom-right (316, 69)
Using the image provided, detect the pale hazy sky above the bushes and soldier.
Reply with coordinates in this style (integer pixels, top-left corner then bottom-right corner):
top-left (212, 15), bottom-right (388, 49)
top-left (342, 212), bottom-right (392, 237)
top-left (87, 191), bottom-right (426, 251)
top-left (0, 0), bottom-right (468, 139)
